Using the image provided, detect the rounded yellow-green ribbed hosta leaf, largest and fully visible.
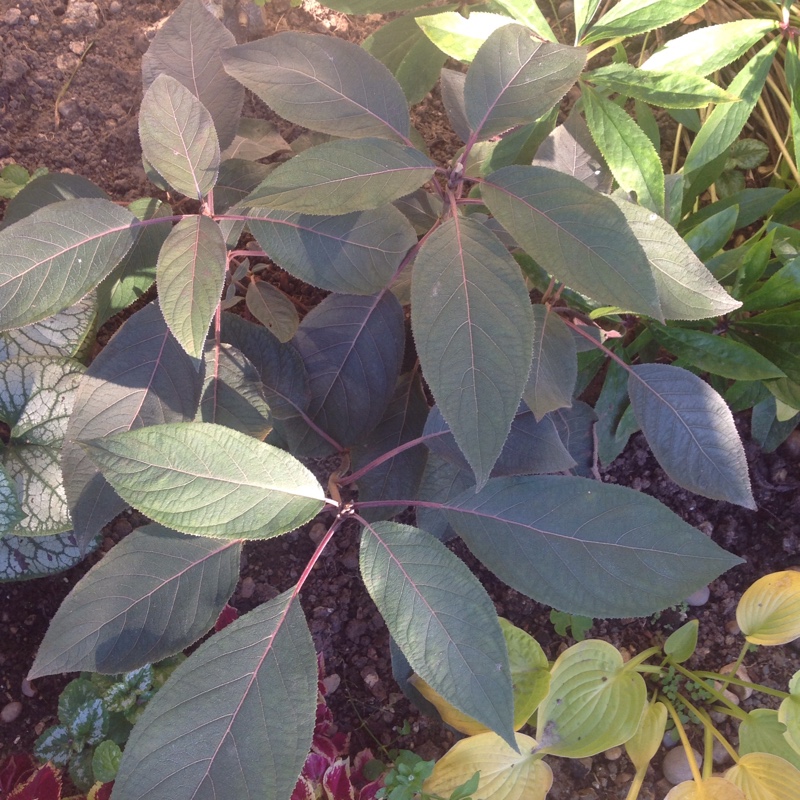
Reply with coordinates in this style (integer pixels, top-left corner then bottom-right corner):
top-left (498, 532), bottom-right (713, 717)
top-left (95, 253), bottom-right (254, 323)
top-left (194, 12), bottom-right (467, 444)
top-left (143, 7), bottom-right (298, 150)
top-left (536, 639), bottom-right (647, 758)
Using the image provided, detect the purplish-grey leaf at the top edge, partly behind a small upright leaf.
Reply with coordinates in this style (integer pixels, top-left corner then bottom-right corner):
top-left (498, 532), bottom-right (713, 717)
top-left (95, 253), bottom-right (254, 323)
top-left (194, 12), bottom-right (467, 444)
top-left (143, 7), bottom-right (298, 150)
top-left (142, 0), bottom-right (244, 149)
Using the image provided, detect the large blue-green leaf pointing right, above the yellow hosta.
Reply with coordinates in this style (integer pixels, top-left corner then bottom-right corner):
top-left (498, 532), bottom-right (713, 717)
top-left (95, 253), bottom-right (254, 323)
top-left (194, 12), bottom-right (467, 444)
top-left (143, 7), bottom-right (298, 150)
top-left (442, 475), bottom-right (740, 618)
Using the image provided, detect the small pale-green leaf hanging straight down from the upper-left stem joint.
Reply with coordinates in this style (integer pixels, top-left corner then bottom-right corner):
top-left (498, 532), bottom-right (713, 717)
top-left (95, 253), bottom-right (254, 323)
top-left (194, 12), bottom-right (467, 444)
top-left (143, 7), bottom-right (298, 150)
top-left (157, 215), bottom-right (227, 358)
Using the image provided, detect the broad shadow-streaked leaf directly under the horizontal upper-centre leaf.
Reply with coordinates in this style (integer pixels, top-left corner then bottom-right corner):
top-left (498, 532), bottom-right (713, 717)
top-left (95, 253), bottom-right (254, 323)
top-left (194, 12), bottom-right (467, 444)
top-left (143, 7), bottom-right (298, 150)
top-left (246, 206), bottom-right (417, 294)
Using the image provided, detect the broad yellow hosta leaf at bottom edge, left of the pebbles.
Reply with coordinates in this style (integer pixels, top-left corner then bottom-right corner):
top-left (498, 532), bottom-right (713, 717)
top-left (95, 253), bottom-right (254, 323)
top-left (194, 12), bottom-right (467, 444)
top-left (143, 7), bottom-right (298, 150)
top-left (422, 733), bottom-right (553, 800)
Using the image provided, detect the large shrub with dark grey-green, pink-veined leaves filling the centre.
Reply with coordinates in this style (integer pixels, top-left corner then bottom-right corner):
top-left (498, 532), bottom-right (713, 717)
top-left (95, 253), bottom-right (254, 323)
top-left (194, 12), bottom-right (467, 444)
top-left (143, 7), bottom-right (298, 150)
top-left (0, 0), bottom-right (768, 800)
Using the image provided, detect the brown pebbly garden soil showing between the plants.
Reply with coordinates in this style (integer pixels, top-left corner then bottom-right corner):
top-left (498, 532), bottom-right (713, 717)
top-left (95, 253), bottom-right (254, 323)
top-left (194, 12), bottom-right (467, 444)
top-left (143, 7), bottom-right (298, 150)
top-left (0, 0), bottom-right (800, 800)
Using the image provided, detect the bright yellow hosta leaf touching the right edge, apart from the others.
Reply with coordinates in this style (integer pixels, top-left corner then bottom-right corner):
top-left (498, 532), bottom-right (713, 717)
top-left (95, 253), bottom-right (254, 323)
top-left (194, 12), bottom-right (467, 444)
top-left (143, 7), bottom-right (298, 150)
top-left (736, 570), bottom-right (800, 645)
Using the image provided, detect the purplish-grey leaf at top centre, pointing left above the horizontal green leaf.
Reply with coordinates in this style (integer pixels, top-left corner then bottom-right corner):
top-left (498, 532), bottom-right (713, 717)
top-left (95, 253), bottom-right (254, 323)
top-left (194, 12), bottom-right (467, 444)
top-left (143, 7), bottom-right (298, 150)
top-left (222, 31), bottom-right (410, 142)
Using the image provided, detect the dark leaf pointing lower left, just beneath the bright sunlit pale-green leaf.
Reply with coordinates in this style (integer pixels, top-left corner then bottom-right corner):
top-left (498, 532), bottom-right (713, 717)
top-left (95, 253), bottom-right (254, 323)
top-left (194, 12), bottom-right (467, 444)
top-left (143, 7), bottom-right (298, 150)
top-left (29, 525), bottom-right (241, 679)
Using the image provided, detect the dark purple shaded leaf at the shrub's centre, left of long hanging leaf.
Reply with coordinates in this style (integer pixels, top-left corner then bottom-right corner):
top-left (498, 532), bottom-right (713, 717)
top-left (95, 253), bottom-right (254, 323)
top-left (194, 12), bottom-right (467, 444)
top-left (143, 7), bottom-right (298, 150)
top-left (294, 292), bottom-right (405, 446)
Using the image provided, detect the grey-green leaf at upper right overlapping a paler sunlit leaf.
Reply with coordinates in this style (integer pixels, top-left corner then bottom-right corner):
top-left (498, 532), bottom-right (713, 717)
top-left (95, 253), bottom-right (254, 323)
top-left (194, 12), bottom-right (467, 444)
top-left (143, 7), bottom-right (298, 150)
top-left (481, 166), bottom-right (662, 319)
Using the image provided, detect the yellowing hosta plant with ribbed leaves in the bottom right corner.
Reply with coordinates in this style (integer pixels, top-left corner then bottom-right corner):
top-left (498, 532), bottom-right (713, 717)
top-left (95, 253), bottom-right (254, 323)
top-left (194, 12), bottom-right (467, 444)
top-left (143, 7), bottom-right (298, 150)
top-left (412, 571), bottom-right (800, 800)
